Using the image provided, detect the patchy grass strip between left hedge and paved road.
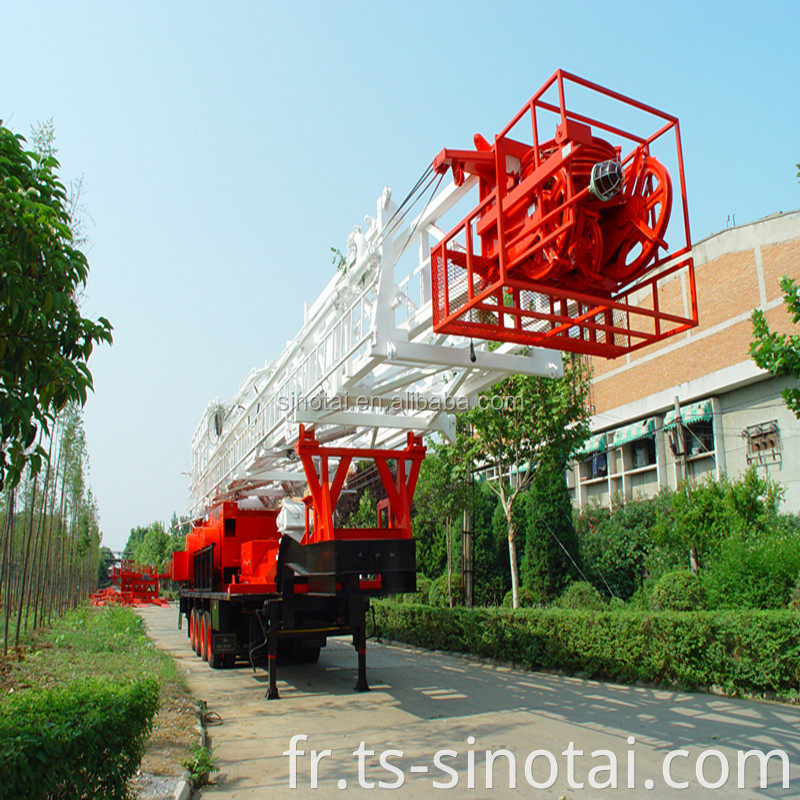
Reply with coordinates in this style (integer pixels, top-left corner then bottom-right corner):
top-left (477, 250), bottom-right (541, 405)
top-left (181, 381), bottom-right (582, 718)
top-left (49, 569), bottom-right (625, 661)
top-left (0, 606), bottom-right (196, 775)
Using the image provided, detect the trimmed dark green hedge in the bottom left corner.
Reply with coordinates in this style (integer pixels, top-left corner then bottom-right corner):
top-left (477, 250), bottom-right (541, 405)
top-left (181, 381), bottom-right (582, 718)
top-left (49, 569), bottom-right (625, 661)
top-left (0, 678), bottom-right (159, 800)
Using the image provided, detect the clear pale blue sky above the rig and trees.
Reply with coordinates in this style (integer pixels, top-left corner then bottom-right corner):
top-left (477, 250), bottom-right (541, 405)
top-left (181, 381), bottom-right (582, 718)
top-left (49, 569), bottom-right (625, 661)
top-left (0, 0), bottom-right (800, 549)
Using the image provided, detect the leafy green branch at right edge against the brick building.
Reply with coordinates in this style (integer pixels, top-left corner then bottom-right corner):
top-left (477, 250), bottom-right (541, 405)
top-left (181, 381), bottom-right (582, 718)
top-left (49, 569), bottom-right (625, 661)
top-left (750, 275), bottom-right (800, 419)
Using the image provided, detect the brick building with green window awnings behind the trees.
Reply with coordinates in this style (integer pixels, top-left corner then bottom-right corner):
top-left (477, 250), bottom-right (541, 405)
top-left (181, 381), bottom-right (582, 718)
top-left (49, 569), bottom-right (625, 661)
top-left (567, 211), bottom-right (800, 512)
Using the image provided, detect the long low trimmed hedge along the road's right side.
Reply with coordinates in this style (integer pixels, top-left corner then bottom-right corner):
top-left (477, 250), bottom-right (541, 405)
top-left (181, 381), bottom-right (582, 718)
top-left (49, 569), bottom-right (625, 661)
top-left (374, 601), bottom-right (800, 699)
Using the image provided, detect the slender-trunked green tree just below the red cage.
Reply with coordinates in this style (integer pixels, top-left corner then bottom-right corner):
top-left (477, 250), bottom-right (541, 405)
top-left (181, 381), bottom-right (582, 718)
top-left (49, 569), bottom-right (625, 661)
top-left (462, 355), bottom-right (590, 608)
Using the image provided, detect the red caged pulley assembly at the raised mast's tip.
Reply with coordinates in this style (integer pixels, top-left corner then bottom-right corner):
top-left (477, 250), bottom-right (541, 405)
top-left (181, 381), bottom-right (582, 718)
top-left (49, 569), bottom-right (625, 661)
top-left (431, 70), bottom-right (697, 358)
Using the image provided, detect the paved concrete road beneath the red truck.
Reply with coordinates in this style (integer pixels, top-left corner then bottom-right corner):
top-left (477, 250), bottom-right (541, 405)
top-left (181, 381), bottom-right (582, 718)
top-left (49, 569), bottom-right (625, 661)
top-left (142, 607), bottom-right (800, 800)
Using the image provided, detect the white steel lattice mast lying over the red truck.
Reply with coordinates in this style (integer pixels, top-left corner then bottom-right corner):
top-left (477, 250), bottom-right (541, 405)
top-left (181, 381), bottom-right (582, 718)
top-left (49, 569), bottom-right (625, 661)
top-left (191, 176), bottom-right (562, 516)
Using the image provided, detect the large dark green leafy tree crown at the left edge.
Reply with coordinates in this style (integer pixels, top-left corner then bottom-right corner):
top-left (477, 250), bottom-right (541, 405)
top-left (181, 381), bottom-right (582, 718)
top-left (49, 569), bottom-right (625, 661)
top-left (0, 122), bottom-right (111, 486)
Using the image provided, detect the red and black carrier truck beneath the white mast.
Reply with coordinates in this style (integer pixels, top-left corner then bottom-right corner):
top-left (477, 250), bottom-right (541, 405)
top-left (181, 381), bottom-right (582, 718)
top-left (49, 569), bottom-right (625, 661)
top-left (172, 426), bottom-right (425, 698)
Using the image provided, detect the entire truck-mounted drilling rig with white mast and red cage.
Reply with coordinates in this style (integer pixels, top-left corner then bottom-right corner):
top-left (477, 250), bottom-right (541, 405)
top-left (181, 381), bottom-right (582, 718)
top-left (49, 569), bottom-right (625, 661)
top-left (167, 70), bottom-right (697, 698)
